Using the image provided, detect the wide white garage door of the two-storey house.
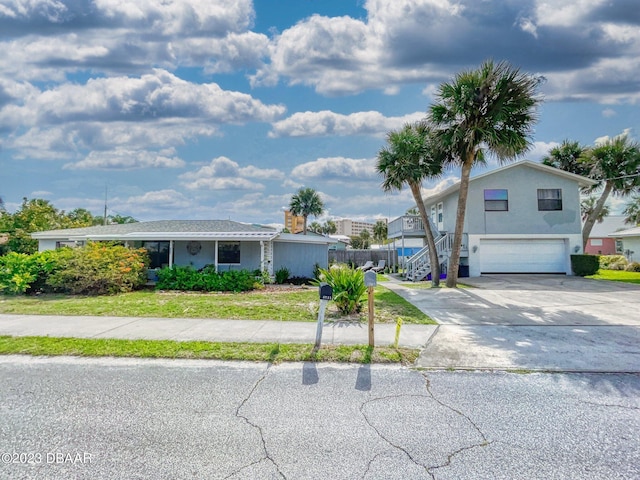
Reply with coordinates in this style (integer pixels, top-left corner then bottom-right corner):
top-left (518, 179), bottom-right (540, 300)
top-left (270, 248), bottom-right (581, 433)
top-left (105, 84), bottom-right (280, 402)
top-left (480, 239), bottom-right (567, 273)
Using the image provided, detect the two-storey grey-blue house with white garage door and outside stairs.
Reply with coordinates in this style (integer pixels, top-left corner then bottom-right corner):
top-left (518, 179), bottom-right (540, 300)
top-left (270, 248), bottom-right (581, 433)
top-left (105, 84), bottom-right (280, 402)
top-left (389, 161), bottom-right (595, 280)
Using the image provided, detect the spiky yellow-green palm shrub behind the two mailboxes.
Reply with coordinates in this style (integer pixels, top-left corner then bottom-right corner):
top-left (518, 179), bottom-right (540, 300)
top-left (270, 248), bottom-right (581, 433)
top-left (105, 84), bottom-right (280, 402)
top-left (314, 265), bottom-right (367, 315)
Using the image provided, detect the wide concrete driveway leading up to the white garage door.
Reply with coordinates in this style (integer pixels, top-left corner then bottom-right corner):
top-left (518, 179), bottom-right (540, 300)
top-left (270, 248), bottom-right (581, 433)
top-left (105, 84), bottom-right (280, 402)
top-left (384, 275), bottom-right (640, 372)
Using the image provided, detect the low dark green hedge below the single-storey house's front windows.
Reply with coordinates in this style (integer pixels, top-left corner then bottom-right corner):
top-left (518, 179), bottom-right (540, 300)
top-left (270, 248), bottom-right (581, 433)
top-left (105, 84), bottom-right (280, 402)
top-left (156, 265), bottom-right (256, 292)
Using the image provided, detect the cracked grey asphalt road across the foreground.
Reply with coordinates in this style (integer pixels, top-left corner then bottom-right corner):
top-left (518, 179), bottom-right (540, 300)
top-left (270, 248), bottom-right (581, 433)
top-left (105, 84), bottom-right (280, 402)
top-left (0, 356), bottom-right (640, 480)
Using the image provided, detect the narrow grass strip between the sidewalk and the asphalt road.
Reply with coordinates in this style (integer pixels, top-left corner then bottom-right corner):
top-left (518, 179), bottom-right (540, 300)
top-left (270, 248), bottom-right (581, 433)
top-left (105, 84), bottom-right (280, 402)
top-left (0, 336), bottom-right (419, 365)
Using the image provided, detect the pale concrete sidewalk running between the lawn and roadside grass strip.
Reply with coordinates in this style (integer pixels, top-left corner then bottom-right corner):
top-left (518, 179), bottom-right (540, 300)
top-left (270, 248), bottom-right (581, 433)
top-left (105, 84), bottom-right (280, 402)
top-left (0, 314), bottom-right (437, 348)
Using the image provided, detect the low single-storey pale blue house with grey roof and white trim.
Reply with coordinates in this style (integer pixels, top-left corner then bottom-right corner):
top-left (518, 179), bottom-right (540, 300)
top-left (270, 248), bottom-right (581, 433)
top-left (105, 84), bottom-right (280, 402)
top-left (31, 220), bottom-right (336, 277)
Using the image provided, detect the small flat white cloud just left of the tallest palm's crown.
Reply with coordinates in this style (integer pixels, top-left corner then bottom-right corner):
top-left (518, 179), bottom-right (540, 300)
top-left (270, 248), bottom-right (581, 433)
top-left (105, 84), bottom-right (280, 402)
top-left (269, 110), bottom-right (426, 137)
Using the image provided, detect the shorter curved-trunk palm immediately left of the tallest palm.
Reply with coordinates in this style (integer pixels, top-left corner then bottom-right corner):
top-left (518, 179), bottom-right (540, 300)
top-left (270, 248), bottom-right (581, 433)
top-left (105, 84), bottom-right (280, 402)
top-left (376, 122), bottom-right (442, 287)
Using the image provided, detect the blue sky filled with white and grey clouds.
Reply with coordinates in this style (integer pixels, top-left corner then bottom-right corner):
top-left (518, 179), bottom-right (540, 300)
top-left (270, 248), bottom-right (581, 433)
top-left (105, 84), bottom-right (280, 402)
top-left (0, 0), bottom-right (640, 224)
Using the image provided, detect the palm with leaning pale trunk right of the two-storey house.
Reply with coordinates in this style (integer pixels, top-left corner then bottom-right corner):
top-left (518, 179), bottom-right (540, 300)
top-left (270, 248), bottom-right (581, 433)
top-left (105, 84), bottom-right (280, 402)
top-left (582, 133), bottom-right (640, 246)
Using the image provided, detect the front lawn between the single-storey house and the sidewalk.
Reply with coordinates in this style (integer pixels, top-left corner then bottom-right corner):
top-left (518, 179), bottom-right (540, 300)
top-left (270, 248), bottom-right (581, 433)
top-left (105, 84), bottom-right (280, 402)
top-left (0, 286), bottom-right (435, 324)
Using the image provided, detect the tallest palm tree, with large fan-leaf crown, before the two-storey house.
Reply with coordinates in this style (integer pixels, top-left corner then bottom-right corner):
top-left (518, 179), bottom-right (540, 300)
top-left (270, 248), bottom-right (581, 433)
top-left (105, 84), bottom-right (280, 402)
top-left (429, 60), bottom-right (540, 287)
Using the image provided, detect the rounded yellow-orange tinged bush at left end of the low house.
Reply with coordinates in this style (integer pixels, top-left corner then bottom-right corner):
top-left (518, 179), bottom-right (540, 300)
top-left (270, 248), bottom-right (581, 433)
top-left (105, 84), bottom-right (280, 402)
top-left (45, 242), bottom-right (149, 295)
